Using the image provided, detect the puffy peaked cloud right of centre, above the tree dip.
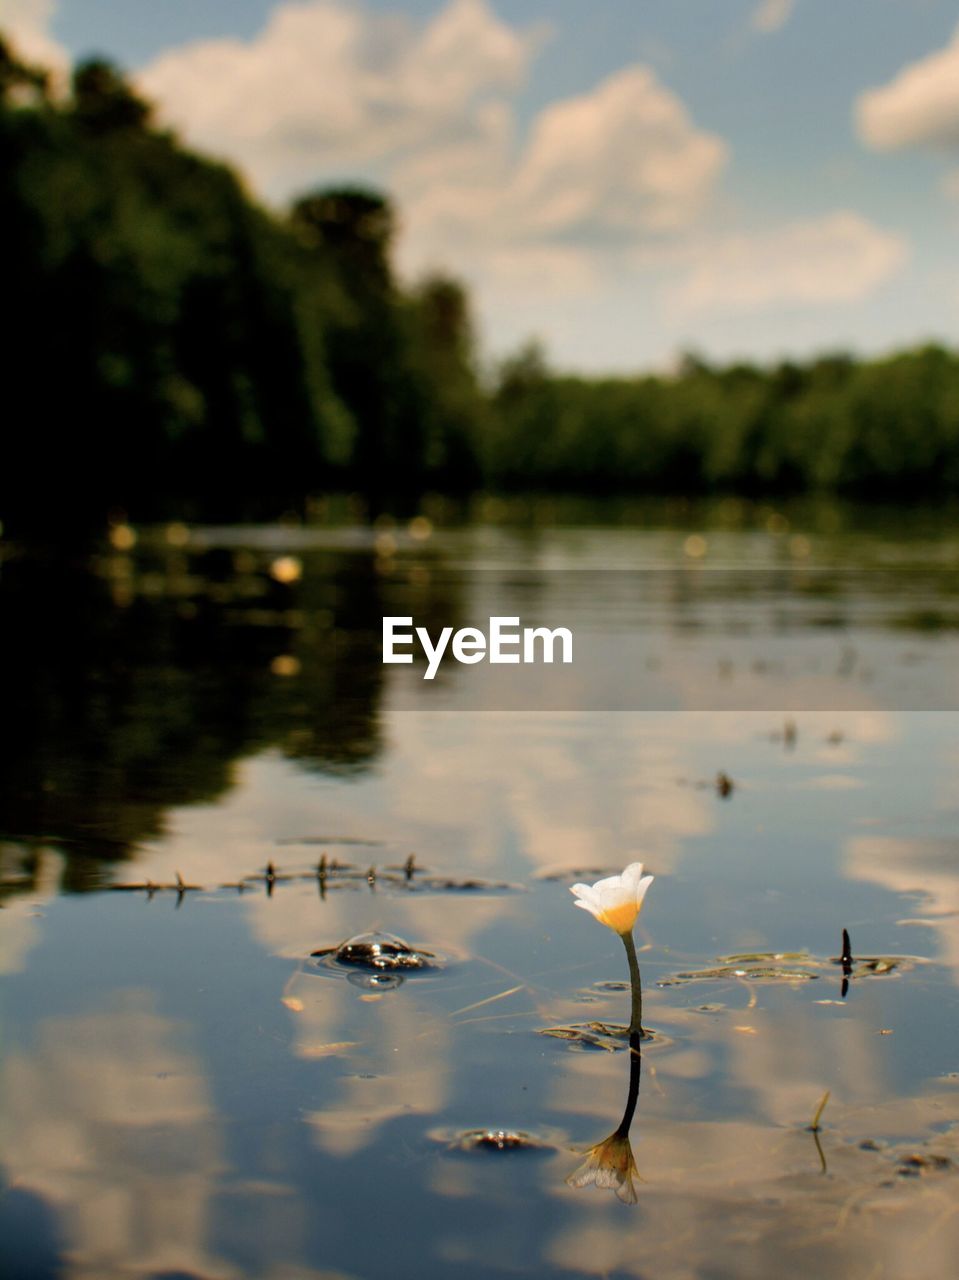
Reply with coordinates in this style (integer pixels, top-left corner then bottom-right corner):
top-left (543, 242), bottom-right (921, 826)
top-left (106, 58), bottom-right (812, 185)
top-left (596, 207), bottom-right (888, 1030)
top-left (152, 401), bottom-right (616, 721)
top-left (394, 65), bottom-right (727, 292)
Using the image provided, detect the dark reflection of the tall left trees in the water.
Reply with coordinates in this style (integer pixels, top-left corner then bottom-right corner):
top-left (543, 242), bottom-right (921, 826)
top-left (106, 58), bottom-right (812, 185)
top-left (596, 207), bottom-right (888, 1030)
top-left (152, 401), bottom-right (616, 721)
top-left (0, 549), bottom-right (456, 900)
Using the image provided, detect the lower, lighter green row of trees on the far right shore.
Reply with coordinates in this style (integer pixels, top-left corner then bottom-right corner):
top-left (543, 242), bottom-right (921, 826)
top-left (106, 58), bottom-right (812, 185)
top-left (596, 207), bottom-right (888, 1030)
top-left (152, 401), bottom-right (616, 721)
top-left (485, 346), bottom-right (959, 499)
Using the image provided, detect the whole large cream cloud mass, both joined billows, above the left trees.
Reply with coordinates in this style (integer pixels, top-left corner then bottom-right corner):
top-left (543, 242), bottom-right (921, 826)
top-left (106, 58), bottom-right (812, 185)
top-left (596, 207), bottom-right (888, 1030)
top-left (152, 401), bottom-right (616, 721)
top-left (137, 0), bottom-right (727, 293)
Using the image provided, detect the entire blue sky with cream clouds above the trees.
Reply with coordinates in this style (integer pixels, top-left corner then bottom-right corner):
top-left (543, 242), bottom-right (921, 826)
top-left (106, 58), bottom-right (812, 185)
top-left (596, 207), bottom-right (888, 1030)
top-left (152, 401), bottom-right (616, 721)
top-left (0, 0), bottom-right (959, 372)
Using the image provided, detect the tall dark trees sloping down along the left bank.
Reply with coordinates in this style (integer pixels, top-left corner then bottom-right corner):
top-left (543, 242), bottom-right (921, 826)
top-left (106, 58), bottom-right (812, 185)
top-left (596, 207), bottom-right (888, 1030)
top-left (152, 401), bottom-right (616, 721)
top-left (0, 45), bottom-right (479, 535)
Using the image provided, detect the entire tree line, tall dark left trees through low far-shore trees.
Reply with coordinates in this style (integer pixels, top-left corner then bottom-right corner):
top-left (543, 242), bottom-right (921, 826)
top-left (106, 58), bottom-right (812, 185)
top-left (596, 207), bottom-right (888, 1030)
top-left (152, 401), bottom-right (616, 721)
top-left (0, 41), bottom-right (959, 534)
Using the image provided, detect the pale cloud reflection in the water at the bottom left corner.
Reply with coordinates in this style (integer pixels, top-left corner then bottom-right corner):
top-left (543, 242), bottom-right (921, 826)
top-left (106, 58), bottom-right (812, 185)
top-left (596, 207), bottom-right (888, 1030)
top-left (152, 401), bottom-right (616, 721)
top-left (3, 991), bottom-right (227, 1280)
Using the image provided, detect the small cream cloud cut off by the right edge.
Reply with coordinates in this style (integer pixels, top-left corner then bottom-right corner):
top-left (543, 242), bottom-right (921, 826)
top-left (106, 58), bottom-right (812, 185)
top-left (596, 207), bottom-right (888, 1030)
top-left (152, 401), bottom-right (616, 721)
top-left (855, 29), bottom-right (959, 151)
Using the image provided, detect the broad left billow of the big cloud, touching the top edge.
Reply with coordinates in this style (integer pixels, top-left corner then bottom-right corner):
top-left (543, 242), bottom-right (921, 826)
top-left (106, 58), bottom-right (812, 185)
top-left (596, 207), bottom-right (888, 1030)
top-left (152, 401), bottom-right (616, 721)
top-left (137, 0), bottom-right (543, 195)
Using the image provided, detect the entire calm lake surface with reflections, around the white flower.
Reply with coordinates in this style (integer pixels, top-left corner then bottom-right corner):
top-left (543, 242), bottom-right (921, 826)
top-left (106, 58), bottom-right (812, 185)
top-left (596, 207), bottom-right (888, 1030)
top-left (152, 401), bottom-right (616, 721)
top-left (0, 508), bottom-right (959, 1280)
